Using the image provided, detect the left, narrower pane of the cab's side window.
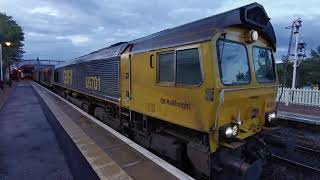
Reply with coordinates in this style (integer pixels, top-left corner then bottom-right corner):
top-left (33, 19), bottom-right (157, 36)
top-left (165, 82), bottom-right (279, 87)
top-left (159, 52), bottom-right (174, 82)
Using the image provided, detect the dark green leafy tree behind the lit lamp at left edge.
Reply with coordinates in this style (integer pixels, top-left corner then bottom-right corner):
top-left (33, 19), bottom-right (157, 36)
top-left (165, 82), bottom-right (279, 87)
top-left (0, 13), bottom-right (24, 67)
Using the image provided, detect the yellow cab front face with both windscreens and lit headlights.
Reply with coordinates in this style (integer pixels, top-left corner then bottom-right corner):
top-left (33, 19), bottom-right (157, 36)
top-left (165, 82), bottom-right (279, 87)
top-left (212, 27), bottom-right (278, 146)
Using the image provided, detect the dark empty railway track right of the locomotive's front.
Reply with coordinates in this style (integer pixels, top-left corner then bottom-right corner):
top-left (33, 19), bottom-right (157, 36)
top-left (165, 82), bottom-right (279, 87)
top-left (262, 120), bottom-right (320, 180)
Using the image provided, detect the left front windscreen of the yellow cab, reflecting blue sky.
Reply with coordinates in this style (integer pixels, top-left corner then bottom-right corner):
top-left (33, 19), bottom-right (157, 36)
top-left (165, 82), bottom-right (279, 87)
top-left (218, 40), bottom-right (250, 85)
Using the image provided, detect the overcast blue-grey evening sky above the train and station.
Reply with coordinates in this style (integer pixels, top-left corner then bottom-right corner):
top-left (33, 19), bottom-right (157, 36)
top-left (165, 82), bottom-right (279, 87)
top-left (0, 0), bottom-right (320, 60)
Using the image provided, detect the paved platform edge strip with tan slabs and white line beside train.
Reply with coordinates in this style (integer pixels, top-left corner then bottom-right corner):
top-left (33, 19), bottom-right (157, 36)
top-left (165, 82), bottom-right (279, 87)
top-left (29, 82), bottom-right (192, 180)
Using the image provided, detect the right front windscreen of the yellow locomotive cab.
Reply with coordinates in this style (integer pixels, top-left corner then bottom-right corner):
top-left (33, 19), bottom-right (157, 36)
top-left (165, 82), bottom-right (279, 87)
top-left (253, 47), bottom-right (276, 83)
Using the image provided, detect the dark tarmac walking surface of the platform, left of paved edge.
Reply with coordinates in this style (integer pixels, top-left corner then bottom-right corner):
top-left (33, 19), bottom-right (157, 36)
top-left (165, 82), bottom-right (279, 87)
top-left (0, 82), bottom-right (73, 180)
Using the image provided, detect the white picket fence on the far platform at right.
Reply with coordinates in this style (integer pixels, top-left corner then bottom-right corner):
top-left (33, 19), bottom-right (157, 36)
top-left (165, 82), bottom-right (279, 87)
top-left (276, 87), bottom-right (320, 107)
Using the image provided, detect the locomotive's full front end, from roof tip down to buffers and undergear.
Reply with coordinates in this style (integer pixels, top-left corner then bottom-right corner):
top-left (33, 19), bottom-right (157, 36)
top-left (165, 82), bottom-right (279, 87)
top-left (209, 7), bottom-right (278, 179)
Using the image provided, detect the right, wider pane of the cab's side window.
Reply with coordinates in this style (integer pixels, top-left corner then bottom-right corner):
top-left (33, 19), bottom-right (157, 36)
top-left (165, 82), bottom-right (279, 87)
top-left (176, 48), bottom-right (202, 85)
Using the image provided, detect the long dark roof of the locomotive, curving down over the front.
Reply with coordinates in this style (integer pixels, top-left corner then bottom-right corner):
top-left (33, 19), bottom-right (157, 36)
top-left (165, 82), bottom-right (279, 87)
top-left (56, 3), bottom-right (276, 68)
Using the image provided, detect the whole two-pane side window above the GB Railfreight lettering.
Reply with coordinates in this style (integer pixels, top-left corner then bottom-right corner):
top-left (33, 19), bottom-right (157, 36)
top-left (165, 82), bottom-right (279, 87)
top-left (158, 48), bottom-right (202, 85)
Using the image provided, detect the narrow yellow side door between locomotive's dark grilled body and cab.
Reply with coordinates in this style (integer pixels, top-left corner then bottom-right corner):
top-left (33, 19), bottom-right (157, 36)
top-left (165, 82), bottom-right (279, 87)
top-left (120, 45), bottom-right (132, 107)
